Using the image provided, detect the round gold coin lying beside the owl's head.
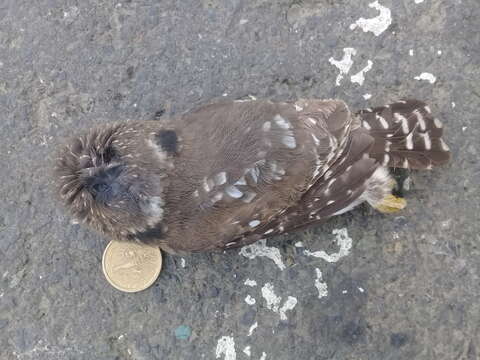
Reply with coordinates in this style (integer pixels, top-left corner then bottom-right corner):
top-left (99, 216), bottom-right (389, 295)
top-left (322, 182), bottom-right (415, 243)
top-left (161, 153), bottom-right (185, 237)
top-left (102, 241), bottom-right (162, 292)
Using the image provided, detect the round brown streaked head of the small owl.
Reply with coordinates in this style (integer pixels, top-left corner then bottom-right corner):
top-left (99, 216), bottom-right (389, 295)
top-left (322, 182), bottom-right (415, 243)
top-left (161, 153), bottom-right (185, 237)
top-left (55, 123), bottom-right (166, 242)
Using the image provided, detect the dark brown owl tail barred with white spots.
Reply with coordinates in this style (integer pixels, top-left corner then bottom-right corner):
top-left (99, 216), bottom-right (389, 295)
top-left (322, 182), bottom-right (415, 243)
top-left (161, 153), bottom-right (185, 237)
top-left (357, 100), bottom-right (450, 169)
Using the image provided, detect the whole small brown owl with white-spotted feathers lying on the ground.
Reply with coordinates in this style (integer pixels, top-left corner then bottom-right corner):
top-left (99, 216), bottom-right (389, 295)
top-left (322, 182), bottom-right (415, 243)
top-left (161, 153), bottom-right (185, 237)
top-left (55, 99), bottom-right (450, 253)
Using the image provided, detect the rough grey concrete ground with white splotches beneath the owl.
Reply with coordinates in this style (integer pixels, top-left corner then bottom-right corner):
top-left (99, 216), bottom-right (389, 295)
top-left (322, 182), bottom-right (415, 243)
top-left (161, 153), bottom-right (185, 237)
top-left (0, 0), bottom-right (480, 360)
